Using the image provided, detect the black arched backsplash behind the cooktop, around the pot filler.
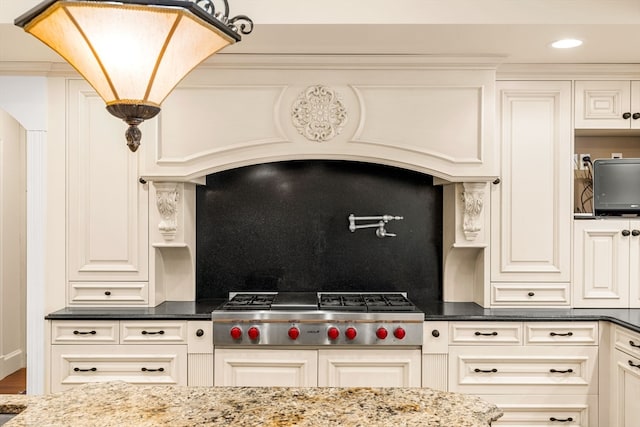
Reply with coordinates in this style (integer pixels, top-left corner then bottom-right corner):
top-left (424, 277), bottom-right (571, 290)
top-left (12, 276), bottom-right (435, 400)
top-left (196, 160), bottom-right (442, 302)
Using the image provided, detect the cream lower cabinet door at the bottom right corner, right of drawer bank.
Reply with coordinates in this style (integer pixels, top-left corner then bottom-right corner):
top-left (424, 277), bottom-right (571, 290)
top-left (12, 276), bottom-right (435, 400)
top-left (609, 350), bottom-right (640, 427)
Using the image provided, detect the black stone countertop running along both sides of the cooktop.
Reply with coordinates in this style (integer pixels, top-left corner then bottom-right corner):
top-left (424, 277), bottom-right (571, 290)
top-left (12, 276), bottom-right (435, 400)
top-left (46, 299), bottom-right (640, 333)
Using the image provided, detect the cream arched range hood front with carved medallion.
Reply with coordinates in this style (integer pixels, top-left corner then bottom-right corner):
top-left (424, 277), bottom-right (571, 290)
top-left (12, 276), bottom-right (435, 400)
top-left (141, 57), bottom-right (499, 183)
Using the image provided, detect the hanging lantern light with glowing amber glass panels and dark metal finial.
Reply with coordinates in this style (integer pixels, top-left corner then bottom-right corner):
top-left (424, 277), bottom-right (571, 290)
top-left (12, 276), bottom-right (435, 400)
top-left (15, 0), bottom-right (253, 151)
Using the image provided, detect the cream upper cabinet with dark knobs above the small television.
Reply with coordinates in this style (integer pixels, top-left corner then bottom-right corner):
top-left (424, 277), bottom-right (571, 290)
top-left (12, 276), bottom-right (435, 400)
top-left (575, 80), bottom-right (640, 129)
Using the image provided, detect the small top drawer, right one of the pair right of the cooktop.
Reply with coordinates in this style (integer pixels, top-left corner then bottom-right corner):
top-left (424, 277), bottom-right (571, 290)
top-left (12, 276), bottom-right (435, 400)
top-left (524, 322), bottom-right (599, 345)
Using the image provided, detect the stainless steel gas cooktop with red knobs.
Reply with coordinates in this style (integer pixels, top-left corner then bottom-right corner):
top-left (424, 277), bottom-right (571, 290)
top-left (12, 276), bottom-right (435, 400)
top-left (212, 292), bottom-right (424, 346)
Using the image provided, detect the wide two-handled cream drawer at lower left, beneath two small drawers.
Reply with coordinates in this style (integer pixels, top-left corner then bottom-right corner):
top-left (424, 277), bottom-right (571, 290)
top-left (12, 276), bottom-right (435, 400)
top-left (51, 345), bottom-right (187, 392)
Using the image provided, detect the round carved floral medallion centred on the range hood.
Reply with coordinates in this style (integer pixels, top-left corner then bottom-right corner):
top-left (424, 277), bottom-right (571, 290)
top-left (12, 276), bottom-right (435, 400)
top-left (291, 85), bottom-right (347, 142)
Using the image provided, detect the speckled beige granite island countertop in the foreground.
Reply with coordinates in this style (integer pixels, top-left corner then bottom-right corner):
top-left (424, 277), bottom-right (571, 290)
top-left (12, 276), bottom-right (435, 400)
top-left (0, 382), bottom-right (502, 427)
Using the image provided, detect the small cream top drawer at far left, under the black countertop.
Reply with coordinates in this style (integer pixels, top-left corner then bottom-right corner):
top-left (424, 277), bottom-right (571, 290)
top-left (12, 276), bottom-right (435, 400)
top-left (51, 320), bottom-right (120, 344)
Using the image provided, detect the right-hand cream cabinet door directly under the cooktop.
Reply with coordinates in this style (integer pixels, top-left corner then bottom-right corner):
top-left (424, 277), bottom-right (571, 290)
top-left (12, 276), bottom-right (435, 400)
top-left (318, 349), bottom-right (422, 387)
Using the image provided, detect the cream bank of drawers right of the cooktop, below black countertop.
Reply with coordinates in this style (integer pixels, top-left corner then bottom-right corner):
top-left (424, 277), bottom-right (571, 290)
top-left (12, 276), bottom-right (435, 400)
top-left (448, 322), bottom-right (599, 427)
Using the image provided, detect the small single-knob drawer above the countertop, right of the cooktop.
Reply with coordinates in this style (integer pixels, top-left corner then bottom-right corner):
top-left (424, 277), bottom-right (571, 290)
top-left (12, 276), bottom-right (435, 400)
top-left (491, 283), bottom-right (571, 306)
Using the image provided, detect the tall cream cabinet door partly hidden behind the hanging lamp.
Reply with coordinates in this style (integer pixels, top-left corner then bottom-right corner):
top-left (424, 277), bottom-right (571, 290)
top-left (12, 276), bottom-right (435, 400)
top-left (67, 80), bottom-right (148, 281)
